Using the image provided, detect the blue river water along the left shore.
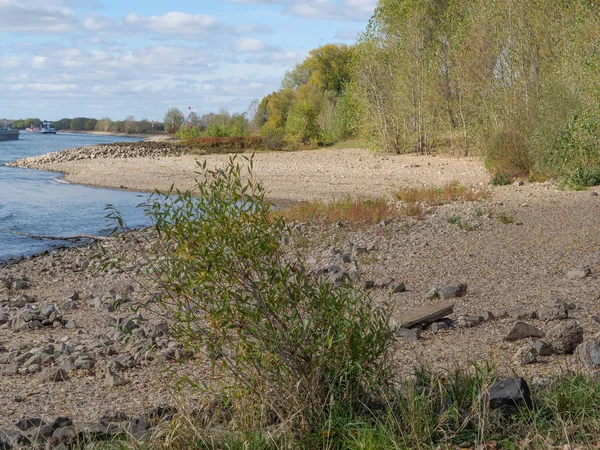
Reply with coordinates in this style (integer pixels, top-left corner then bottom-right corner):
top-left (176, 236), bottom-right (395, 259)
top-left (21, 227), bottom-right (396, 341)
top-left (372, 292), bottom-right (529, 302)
top-left (0, 132), bottom-right (148, 261)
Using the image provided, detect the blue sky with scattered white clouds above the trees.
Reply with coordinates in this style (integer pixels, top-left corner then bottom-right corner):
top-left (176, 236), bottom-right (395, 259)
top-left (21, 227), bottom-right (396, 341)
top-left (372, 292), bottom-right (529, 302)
top-left (0, 0), bottom-right (377, 121)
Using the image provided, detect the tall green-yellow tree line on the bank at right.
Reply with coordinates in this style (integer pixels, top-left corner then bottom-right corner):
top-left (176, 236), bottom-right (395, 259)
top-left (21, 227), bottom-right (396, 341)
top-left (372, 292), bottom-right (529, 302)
top-left (250, 0), bottom-right (600, 182)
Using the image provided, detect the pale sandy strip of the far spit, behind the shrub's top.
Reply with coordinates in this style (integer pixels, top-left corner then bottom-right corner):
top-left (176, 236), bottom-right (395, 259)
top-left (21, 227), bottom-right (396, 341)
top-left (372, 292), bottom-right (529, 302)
top-left (35, 149), bottom-right (489, 201)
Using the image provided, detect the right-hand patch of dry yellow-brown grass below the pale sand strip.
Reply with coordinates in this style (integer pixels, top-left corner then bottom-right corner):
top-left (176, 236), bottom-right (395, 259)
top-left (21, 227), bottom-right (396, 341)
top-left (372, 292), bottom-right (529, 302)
top-left (394, 181), bottom-right (489, 206)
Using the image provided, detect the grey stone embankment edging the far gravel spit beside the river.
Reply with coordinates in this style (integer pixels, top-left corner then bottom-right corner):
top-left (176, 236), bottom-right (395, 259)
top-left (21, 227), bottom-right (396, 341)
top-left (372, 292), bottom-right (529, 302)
top-left (5, 142), bottom-right (189, 169)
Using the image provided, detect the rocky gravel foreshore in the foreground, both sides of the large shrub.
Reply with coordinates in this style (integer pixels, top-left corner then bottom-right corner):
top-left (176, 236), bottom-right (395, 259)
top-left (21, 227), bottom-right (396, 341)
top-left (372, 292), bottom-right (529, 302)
top-left (0, 144), bottom-right (600, 448)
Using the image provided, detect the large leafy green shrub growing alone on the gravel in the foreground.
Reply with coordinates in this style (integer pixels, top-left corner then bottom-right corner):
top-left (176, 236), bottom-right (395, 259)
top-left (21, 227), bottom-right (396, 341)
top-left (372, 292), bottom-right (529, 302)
top-left (135, 157), bottom-right (391, 430)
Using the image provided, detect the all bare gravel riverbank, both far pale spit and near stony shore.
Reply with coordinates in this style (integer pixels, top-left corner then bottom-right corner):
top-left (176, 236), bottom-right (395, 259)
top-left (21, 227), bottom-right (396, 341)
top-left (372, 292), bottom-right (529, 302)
top-left (0, 144), bottom-right (600, 446)
